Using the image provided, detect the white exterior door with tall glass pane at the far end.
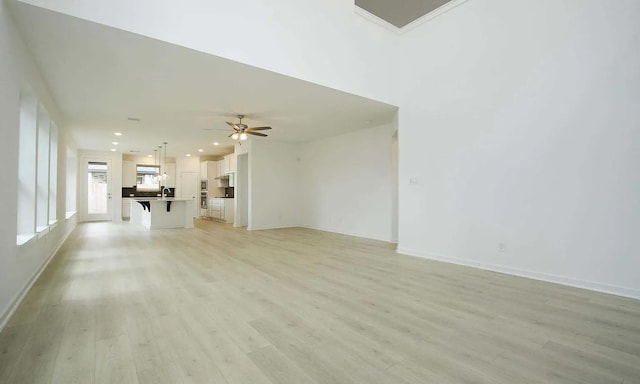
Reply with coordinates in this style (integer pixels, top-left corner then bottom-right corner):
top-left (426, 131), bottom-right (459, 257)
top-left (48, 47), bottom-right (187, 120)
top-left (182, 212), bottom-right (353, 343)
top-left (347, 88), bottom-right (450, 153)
top-left (84, 159), bottom-right (113, 221)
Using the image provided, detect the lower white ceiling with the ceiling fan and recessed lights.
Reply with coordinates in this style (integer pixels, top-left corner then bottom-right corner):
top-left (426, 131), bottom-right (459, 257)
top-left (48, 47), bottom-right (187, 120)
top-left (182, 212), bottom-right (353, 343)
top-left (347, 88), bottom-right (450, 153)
top-left (10, 1), bottom-right (396, 156)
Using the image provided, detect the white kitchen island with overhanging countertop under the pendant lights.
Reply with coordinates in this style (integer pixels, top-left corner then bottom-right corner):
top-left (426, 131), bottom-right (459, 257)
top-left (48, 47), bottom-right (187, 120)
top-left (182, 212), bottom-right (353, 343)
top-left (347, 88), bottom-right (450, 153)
top-left (130, 197), bottom-right (194, 229)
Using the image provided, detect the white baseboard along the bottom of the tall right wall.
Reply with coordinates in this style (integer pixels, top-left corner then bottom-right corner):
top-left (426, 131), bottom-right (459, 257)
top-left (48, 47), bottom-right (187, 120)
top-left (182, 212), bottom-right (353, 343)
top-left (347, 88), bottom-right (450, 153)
top-left (396, 248), bottom-right (640, 299)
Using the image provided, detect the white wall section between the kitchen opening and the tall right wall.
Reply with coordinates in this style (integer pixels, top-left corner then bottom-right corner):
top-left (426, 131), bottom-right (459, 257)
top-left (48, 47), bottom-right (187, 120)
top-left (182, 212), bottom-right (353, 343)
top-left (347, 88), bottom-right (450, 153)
top-left (299, 124), bottom-right (396, 241)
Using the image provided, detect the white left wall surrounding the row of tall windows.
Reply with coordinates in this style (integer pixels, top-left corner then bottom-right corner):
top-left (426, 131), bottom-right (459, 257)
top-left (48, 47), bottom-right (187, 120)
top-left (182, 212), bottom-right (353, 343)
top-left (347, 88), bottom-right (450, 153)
top-left (0, 1), bottom-right (75, 328)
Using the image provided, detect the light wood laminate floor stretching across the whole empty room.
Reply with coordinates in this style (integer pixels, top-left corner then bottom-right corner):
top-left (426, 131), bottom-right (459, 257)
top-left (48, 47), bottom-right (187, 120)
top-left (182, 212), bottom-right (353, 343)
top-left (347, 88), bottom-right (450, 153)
top-left (0, 221), bottom-right (640, 384)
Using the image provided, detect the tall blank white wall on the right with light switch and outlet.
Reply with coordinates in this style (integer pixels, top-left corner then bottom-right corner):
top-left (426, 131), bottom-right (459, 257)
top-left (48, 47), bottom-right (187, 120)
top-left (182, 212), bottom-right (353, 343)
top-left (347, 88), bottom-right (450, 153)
top-left (400, 0), bottom-right (640, 297)
